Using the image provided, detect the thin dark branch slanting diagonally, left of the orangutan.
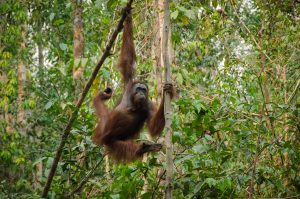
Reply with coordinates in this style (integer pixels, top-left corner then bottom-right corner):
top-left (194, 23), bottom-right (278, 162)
top-left (41, 0), bottom-right (133, 198)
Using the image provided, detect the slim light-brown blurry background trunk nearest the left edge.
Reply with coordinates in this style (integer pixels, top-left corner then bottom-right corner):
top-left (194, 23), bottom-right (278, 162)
top-left (17, 24), bottom-right (27, 135)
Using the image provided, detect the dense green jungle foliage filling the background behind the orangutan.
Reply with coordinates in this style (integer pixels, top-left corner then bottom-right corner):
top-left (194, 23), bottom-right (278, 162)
top-left (0, 0), bottom-right (300, 199)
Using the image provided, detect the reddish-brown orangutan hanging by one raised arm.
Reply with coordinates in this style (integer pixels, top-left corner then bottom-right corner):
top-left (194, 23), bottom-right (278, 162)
top-left (92, 10), bottom-right (175, 163)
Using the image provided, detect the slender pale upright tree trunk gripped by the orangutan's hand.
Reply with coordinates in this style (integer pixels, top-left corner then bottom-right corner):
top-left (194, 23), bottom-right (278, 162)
top-left (162, 0), bottom-right (173, 199)
